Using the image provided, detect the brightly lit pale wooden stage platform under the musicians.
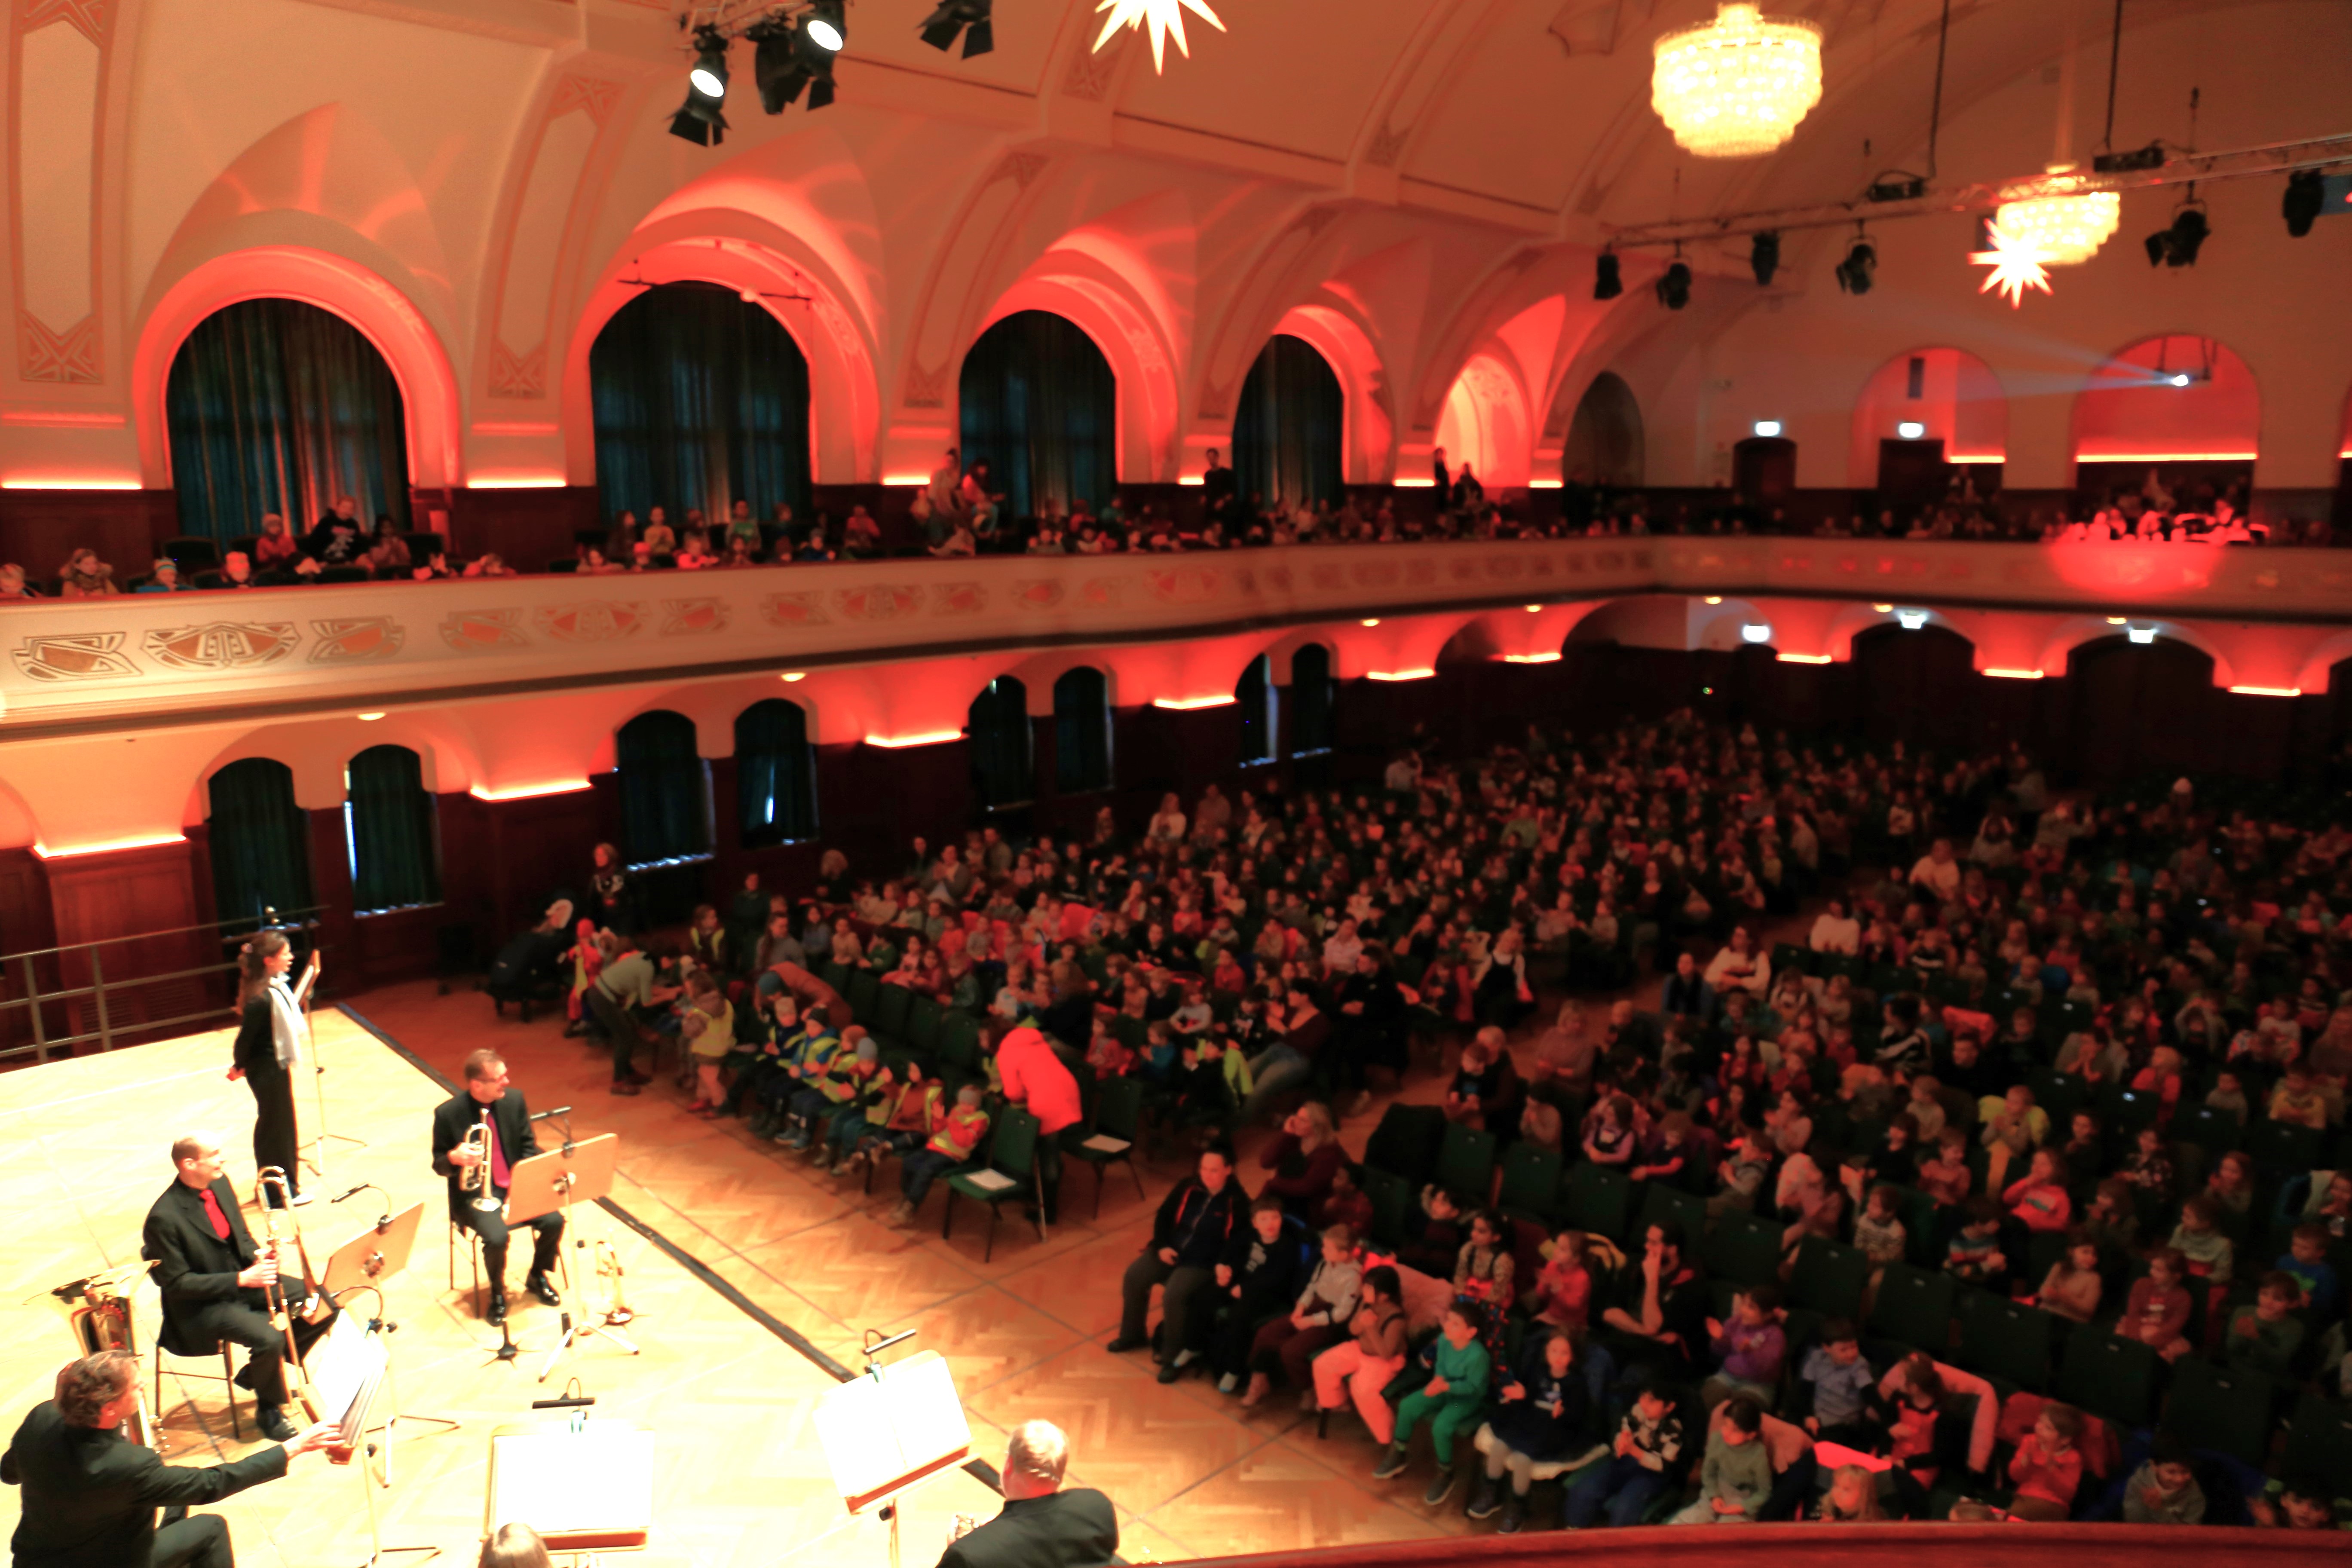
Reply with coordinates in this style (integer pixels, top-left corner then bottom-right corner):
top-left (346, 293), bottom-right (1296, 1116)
top-left (0, 1008), bottom-right (1004, 1568)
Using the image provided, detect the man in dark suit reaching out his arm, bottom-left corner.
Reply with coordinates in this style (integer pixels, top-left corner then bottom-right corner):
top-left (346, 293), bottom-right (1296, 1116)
top-left (0, 1349), bottom-right (341, 1568)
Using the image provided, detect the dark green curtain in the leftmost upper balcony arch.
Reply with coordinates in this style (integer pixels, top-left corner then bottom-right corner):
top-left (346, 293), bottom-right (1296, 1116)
top-left (162, 299), bottom-right (409, 541)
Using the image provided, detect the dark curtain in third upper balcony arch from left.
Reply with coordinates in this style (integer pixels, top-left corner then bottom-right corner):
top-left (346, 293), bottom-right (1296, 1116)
top-left (955, 310), bottom-right (1120, 517)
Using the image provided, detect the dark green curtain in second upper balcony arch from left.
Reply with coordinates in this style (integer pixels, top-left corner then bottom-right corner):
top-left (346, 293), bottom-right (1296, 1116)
top-left (588, 282), bottom-right (809, 543)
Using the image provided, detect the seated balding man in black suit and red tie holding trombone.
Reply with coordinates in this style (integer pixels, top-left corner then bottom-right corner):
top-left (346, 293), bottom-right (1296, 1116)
top-left (139, 1133), bottom-right (334, 1443)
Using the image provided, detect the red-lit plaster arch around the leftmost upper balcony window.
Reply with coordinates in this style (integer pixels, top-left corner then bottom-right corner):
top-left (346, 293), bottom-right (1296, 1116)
top-left (132, 242), bottom-right (463, 489)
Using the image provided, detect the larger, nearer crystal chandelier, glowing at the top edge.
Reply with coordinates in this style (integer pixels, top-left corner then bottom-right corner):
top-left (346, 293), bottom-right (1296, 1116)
top-left (1649, 0), bottom-right (1820, 157)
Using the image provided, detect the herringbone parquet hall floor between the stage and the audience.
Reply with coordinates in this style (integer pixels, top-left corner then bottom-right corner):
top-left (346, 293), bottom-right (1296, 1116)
top-left (350, 983), bottom-right (1486, 1568)
